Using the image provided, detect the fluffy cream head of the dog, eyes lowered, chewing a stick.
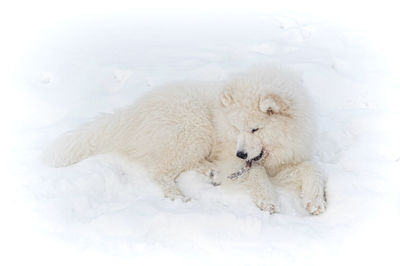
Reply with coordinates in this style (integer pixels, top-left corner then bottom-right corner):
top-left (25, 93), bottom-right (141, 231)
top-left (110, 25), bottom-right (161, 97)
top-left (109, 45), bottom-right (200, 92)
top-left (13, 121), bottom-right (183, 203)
top-left (220, 66), bottom-right (301, 164)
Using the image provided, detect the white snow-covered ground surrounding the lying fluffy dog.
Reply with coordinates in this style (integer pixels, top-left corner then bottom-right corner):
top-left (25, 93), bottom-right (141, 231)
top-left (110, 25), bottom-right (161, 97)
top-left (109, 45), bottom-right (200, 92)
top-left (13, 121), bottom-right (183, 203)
top-left (1, 5), bottom-right (400, 265)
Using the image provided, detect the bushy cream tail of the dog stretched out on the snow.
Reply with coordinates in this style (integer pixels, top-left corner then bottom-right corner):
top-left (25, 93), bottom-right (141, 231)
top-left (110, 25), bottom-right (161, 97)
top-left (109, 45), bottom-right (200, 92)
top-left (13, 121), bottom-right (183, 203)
top-left (43, 111), bottom-right (129, 167)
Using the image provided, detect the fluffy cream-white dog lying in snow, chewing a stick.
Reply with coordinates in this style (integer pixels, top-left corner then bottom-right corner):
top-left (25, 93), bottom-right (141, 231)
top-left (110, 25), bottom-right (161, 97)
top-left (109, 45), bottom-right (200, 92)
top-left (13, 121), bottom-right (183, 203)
top-left (44, 67), bottom-right (325, 214)
